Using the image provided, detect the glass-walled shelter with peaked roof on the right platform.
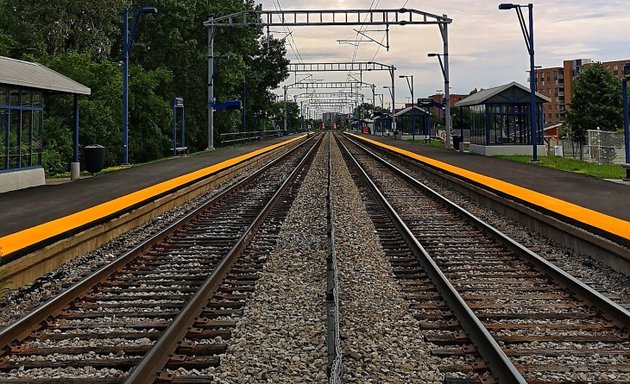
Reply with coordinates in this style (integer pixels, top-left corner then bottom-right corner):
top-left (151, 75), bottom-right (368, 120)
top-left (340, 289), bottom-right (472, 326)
top-left (455, 82), bottom-right (550, 156)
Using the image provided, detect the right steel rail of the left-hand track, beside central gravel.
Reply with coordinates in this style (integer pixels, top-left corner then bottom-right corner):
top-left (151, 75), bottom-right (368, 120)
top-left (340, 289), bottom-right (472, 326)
top-left (125, 137), bottom-right (322, 384)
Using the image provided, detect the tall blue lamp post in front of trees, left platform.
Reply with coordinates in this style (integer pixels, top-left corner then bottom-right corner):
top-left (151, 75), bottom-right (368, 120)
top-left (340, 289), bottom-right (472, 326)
top-left (122, 7), bottom-right (157, 166)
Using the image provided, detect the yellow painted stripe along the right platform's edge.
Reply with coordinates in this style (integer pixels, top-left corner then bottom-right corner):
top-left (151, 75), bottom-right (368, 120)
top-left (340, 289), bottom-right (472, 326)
top-left (351, 134), bottom-right (630, 239)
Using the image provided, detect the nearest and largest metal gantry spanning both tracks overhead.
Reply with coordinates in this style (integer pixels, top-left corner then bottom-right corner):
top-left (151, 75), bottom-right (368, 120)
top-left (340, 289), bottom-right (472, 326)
top-left (204, 8), bottom-right (453, 149)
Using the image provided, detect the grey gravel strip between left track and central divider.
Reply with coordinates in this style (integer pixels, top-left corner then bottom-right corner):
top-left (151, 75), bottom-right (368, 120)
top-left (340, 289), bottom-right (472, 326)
top-left (214, 136), bottom-right (334, 383)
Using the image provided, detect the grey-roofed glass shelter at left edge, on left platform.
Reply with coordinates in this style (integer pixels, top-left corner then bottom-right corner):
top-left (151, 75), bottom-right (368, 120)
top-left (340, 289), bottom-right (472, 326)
top-left (0, 56), bottom-right (91, 193)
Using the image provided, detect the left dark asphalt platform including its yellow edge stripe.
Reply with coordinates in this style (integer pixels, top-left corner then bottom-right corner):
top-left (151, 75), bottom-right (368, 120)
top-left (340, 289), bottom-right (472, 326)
top-left (0, 136), bottom-right (302, 256)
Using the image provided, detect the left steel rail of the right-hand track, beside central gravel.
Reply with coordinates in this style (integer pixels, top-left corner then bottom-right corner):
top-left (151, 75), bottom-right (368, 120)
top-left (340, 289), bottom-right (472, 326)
top-left (340, 139), bottom-right (527, 384)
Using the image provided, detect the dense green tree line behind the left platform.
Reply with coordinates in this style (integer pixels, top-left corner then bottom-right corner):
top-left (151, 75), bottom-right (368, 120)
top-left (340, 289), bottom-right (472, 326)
top-left (0, 0), bottom-right (297, 174)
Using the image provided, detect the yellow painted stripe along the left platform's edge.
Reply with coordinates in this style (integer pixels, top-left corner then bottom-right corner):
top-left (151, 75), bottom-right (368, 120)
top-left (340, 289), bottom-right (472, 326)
top-left (0, 135), bottom-right (305, 256)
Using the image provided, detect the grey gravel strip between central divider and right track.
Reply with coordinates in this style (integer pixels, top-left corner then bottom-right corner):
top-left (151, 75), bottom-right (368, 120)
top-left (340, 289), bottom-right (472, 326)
top-left (333, 136), bottom-right (444, 383)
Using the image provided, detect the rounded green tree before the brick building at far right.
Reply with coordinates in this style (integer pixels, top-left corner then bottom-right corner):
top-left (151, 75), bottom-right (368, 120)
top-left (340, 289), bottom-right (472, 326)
top-left (567, 63), bottom-right (623, 144)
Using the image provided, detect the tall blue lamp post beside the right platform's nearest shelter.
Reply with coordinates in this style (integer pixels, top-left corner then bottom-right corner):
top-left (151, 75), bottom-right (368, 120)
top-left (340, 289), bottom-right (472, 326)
top-left (499, 3), bottom-right (538, 162)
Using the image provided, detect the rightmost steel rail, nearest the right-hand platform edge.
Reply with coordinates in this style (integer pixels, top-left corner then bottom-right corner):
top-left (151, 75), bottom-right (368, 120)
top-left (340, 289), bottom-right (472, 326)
top-left (349, 135), bottom-right (630, 330)
